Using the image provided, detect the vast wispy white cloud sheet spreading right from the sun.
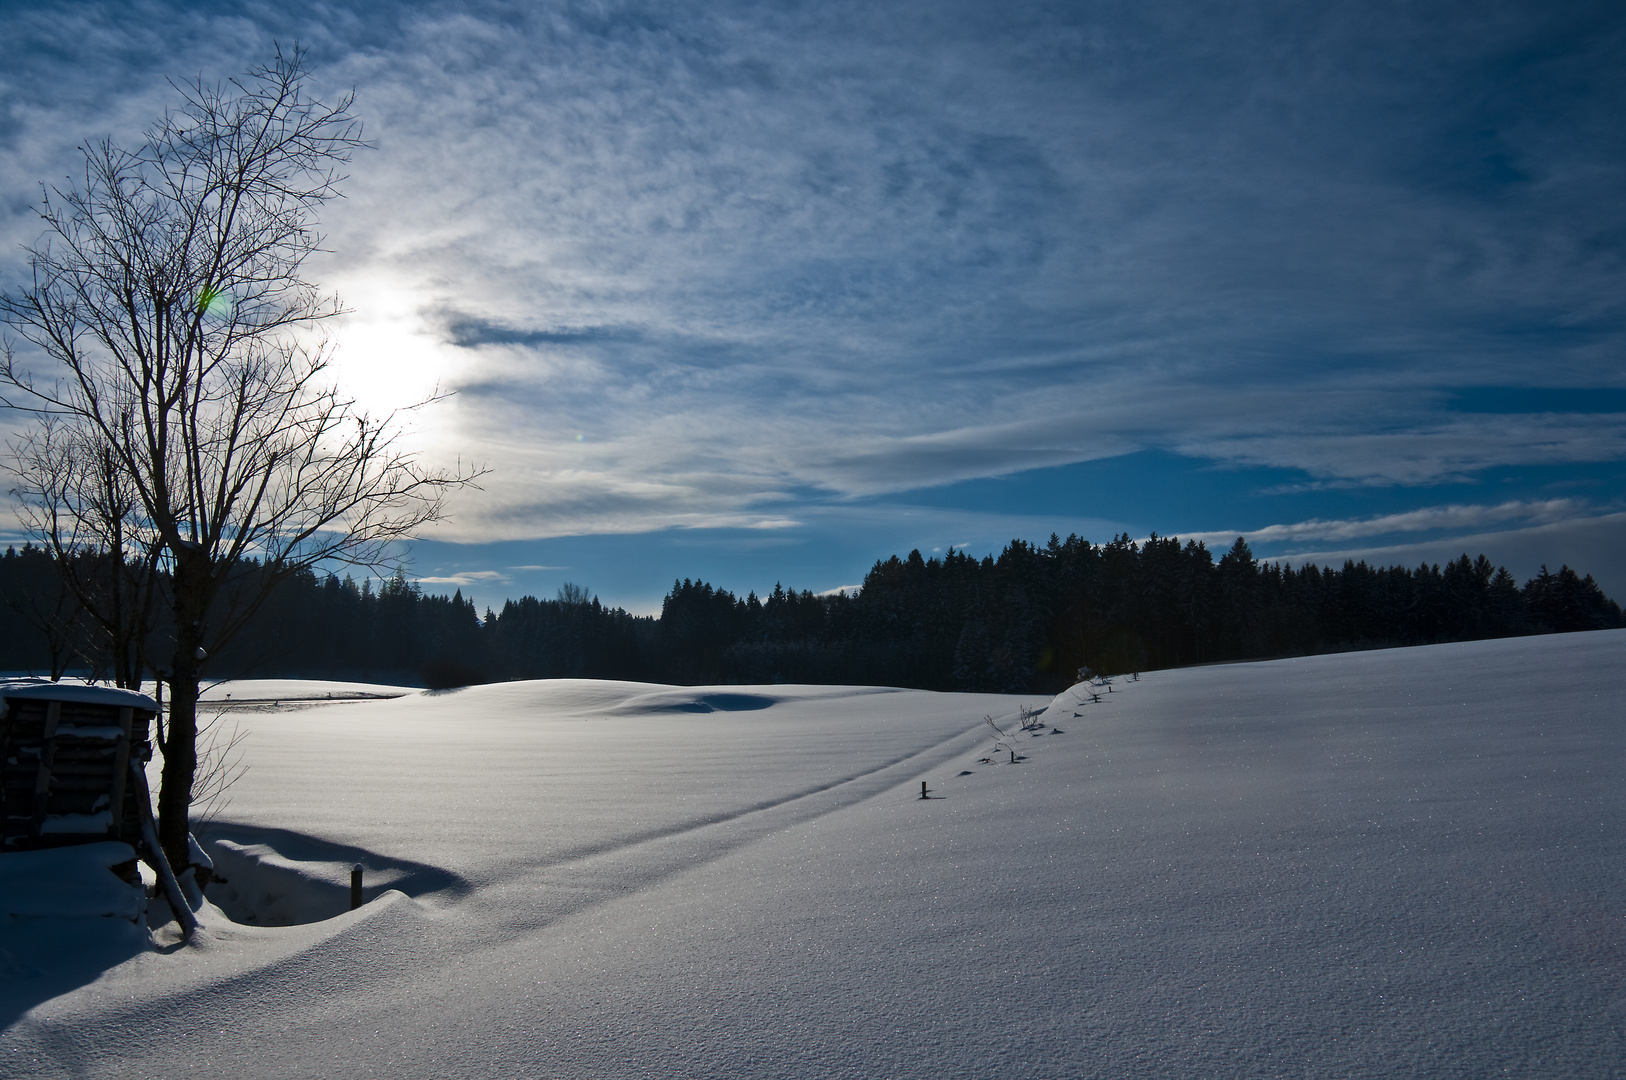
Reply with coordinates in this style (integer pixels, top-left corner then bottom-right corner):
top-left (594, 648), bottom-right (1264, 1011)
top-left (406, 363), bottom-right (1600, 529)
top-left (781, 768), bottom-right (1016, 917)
top-left (302, 1), bottom-right (1621, 535)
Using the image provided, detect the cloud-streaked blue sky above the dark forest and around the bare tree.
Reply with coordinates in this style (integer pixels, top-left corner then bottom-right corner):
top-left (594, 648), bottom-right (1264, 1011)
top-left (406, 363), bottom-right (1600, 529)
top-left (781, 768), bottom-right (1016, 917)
top-left (0, 2), bottom-right (1626, 612)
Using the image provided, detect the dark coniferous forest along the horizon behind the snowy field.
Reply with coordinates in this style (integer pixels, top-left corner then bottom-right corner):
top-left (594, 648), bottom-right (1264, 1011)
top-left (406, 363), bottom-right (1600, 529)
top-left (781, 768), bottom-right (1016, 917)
top-left (0, 535), bottom-right (1626, 693)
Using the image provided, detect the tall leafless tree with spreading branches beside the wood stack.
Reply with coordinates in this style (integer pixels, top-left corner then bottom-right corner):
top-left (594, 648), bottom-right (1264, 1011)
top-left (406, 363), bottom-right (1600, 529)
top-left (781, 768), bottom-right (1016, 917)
top-left (0, 50), bottom-right (473, 865)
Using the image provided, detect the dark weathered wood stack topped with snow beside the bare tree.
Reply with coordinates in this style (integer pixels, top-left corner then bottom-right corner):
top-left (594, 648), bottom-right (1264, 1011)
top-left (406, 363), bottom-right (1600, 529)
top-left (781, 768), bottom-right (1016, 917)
top-left (0, 682), bottom-right (158, 852)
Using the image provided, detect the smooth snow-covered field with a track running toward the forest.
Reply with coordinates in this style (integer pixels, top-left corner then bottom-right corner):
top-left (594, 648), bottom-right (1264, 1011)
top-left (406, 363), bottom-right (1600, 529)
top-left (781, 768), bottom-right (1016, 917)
top-left (0, 631), bottom-right (1626, 1078)
